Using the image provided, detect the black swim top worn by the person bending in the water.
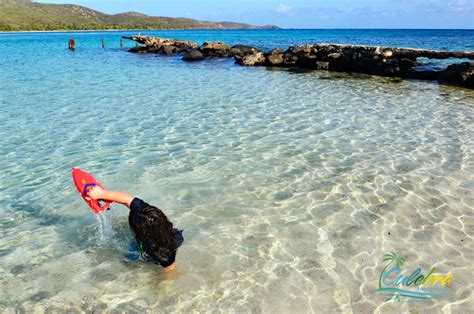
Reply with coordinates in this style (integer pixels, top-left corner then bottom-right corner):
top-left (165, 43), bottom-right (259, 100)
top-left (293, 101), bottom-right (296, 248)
top-left (124, 197), bottom-right (184, 267)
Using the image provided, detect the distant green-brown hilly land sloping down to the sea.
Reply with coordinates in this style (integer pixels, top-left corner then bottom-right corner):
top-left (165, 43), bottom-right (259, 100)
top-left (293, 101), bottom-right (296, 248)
top-left (0, 0), bottom-right (279, 31)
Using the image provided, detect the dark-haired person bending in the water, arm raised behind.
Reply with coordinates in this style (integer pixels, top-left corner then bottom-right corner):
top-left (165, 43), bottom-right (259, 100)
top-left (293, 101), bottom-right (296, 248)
top-left (86, 186), bottom-right (183, 272)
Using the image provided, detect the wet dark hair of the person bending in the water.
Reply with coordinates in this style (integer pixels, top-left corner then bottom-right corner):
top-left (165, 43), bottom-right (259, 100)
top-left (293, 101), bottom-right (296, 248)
top-left (128, 206), bottom-right (176, 267)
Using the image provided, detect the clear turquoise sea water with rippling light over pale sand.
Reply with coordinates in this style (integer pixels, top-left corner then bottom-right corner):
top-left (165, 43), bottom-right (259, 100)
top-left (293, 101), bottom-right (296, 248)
top-left (0, 31), bottom-right (474, 313)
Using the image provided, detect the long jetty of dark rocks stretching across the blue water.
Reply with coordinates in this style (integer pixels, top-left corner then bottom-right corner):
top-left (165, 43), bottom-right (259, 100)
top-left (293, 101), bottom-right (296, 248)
top-left (124, 36), bottom-right (474, 88)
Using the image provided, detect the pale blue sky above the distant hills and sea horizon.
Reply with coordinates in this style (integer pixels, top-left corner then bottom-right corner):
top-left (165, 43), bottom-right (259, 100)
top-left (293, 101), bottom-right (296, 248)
top-left (37, 0), bottom-right (474, 29)
